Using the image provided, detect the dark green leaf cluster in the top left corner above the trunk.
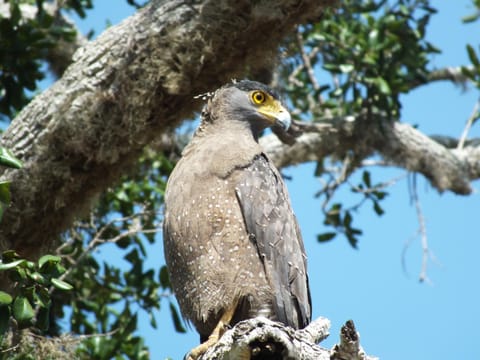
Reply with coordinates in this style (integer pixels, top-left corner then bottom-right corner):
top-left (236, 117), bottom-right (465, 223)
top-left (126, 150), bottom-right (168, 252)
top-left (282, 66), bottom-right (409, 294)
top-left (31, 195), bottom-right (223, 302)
top-left (0, 0), bottom-right (91, 120)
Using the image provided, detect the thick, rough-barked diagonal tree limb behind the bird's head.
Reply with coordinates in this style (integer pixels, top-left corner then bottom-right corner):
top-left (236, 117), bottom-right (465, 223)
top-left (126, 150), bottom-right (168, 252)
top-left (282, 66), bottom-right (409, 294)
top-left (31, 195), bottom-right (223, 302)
top-left (0, 0), bottom-right (333, 257)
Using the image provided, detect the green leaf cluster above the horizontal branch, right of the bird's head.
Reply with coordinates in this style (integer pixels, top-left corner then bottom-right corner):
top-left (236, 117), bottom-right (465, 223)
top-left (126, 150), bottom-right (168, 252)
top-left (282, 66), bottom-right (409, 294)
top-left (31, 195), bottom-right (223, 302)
top-left (287, 0), bottom-right (439, 118)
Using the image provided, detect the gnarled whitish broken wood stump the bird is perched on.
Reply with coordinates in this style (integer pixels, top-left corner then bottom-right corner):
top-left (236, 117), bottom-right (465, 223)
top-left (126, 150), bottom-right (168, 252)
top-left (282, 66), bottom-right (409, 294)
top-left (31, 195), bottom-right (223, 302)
top-left (199, 317), bottom-right (375, 360)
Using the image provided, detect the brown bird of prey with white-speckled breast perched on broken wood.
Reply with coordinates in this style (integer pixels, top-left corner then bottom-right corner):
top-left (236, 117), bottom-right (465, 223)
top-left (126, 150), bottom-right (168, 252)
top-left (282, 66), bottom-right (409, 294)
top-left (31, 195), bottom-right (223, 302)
top-left (163, 80), bottom-right (311, 359)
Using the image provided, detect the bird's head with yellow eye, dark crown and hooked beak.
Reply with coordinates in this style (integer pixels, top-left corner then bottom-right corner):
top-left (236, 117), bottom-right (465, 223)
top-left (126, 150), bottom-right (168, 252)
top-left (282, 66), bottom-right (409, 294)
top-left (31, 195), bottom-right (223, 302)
top-left (200, 80), bottom-right (291, 136)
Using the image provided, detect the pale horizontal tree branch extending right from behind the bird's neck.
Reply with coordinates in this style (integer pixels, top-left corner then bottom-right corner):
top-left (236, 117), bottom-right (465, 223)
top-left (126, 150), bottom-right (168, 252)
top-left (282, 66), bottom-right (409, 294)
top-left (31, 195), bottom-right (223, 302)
top-left (260, 115), bottom-right (480, 195)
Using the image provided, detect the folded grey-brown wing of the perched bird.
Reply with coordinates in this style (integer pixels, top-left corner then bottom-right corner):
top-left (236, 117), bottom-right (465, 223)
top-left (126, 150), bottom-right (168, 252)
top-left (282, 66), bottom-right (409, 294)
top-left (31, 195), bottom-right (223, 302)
top-left (235, 154), bottom-right (311, 328)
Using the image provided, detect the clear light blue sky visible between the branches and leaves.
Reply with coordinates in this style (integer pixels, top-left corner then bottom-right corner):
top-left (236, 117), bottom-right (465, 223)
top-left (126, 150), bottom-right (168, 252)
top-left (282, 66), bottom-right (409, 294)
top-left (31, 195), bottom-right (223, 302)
top-left (68, 0), bottom-right (480, 360)
